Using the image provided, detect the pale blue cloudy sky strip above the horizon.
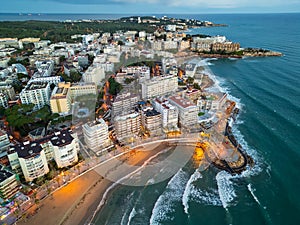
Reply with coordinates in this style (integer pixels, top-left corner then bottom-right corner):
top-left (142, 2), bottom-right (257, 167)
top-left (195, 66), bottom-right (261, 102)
top-left (0, 0), bottom-right (300, 14)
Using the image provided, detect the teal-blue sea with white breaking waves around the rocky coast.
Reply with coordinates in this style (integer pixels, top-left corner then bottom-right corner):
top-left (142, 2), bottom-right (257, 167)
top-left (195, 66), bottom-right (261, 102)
top-left (0, 13), bottom-right (300, 225)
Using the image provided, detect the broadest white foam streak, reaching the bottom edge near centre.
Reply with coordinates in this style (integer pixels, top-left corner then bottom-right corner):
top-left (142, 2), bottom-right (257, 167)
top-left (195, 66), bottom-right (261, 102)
top-left (150, 169), bottom-right (187, 225)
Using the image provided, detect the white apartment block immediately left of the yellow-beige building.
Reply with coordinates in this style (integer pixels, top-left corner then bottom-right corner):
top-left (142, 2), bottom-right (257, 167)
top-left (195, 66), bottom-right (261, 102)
top-left (20, 82), bottom-right (51, 109)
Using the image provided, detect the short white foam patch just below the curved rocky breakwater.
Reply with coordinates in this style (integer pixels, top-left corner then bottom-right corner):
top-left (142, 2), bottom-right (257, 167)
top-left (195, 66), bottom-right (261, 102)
top-left (216, 171), bottom-right (236, 209)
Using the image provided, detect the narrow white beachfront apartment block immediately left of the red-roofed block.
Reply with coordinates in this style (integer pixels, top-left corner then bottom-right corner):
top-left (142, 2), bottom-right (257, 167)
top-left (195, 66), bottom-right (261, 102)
top-left (154, 98), bottom-right (178, 130)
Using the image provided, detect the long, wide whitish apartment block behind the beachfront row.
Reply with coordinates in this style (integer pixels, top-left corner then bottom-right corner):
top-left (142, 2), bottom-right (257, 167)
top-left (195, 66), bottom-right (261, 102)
top-left (142, 75), bottom-right (178, 99)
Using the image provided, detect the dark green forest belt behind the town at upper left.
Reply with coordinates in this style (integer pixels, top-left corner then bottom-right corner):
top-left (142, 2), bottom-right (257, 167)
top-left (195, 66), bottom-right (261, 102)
top-left (0, 20), bottom-right (155, 43)
